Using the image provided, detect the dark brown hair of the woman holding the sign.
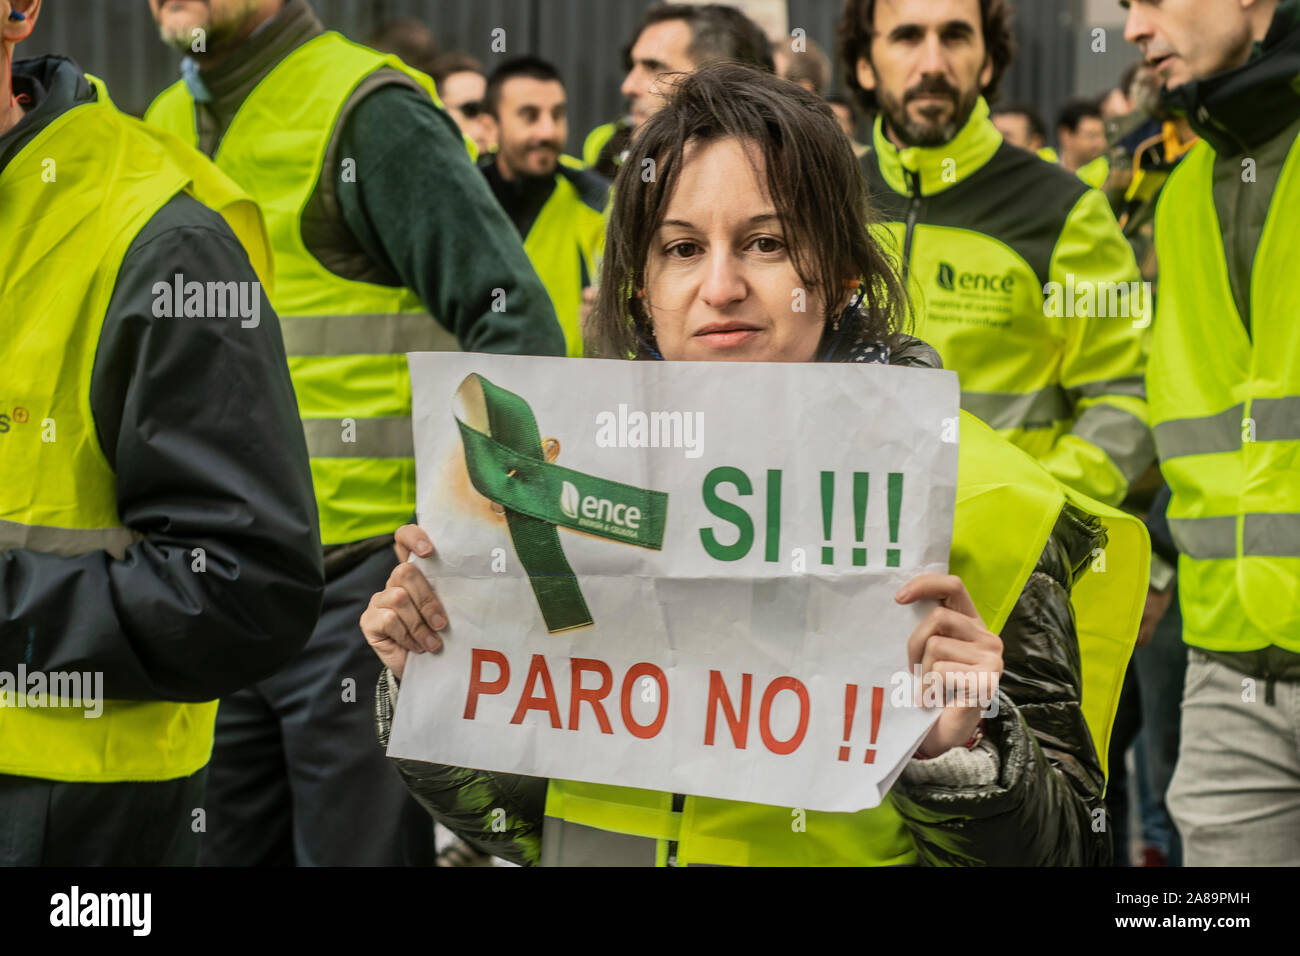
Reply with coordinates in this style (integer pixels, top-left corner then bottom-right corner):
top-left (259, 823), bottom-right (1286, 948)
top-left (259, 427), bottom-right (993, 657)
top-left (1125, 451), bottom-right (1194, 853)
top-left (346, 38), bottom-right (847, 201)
top-left (588, 64), bottom-right (906, 358)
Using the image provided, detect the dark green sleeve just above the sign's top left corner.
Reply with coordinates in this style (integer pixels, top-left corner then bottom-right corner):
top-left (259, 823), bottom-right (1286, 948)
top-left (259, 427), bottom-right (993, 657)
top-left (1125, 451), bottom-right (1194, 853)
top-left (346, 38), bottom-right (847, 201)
top-left (335, 83), bottom-right (564, 355)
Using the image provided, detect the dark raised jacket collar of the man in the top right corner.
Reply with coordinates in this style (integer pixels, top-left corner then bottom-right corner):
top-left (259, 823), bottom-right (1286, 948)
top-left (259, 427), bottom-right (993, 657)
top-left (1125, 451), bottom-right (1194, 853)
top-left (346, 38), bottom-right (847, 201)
top-left (1164, 0), bottom-right (1300, 156)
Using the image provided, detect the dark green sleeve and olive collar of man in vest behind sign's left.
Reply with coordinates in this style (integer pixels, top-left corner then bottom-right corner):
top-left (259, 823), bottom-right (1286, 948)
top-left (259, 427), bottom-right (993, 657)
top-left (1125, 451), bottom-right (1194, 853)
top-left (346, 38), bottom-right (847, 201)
top-left (182, 0), bottom-right (564, 355)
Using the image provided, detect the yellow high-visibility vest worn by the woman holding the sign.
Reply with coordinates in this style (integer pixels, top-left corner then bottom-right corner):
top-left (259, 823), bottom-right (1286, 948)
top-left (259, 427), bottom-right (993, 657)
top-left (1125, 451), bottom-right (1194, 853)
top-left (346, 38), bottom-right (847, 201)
top-left (541, 412), bottom-right (1151, 866)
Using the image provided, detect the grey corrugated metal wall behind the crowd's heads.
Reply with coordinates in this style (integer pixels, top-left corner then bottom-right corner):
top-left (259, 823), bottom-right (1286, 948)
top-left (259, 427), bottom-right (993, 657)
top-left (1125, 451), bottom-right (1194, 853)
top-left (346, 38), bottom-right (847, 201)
top-left (20, 0), bottom-right (1082, 152)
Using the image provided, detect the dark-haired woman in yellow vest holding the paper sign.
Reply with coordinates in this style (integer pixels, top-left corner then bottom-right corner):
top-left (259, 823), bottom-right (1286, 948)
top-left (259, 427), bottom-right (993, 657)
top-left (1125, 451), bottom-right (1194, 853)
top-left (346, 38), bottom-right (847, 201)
top-left (361, 65), bottom-right (1147, 865)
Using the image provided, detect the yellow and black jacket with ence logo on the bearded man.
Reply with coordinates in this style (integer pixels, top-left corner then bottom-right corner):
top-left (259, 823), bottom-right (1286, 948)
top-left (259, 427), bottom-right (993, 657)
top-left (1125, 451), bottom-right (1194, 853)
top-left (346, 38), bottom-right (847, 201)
top-left (861, 99), bottom-right (1154, 505)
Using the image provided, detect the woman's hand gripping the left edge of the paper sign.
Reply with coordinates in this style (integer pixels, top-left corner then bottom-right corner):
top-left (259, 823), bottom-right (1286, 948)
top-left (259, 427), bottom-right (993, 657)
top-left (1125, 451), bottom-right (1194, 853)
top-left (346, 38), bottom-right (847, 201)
top-left (361, 524), bottom-right (447, 678)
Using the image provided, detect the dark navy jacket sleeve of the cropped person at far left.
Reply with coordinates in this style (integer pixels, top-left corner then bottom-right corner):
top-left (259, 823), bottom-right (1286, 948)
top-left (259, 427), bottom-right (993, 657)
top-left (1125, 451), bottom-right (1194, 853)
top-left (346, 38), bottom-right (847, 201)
top-left (0, 195), bottom-right (324, 701)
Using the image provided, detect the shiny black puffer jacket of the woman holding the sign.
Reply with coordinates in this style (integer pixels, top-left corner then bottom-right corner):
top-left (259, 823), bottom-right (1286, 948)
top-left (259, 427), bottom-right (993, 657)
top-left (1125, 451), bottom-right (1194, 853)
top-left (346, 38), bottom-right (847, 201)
top-left (374, 339), bottom-right (1110, 866)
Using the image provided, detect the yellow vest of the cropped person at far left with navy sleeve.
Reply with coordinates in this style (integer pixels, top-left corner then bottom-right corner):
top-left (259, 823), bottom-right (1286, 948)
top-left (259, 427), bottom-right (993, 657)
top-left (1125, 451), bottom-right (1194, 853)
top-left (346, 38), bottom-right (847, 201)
top-left (0, 78), bottom-right (263, 783)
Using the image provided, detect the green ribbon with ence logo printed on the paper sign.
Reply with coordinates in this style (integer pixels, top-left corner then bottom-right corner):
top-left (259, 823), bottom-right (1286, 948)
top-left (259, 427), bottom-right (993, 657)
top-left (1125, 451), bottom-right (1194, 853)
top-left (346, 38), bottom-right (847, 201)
top-left (456, 375), bottom-right (668, 633)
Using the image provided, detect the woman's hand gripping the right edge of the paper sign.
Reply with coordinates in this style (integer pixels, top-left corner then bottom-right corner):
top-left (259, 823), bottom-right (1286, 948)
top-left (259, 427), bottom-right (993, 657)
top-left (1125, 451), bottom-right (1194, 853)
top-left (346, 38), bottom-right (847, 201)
top-left (894, 575), bottom-right (1002, 757)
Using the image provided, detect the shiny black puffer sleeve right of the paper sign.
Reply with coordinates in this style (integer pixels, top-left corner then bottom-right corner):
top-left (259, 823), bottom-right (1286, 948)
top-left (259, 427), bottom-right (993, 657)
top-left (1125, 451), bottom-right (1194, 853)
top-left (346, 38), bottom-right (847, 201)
top-left (889, 506), bottom-right (1112, 866)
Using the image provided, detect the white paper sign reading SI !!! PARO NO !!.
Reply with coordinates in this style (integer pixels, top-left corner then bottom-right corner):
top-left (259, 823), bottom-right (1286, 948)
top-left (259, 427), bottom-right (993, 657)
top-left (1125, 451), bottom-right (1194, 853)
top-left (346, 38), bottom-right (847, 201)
top-left (389, 352), bottom-right (958, 812)
